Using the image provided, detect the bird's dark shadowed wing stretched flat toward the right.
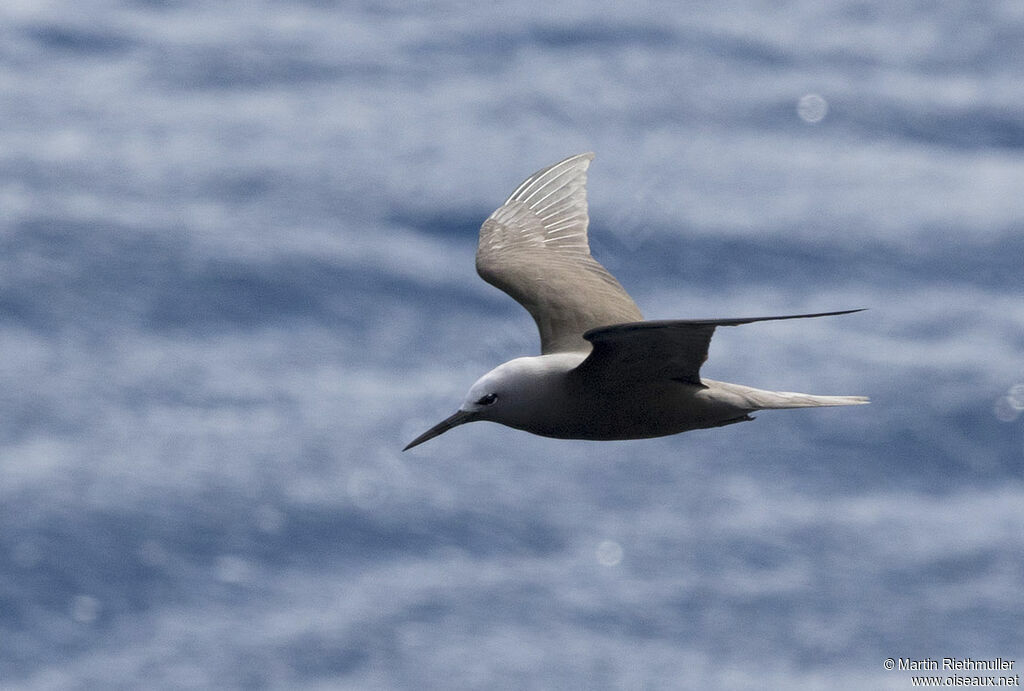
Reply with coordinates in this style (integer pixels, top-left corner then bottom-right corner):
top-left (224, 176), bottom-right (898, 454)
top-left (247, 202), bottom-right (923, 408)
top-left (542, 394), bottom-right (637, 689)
top-left (572, 309), bottom-right (861, 388)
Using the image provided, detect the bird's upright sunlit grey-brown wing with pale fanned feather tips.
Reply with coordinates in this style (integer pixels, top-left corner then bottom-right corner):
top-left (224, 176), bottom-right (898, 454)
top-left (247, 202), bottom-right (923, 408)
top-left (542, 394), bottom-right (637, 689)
top-left (476, 154), bottom-right (643, 354)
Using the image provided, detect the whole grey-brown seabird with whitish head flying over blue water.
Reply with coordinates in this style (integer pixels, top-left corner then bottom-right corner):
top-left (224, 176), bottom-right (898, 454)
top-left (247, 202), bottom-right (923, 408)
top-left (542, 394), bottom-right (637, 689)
top-left (402, 154), bottom-right (867, 450)
